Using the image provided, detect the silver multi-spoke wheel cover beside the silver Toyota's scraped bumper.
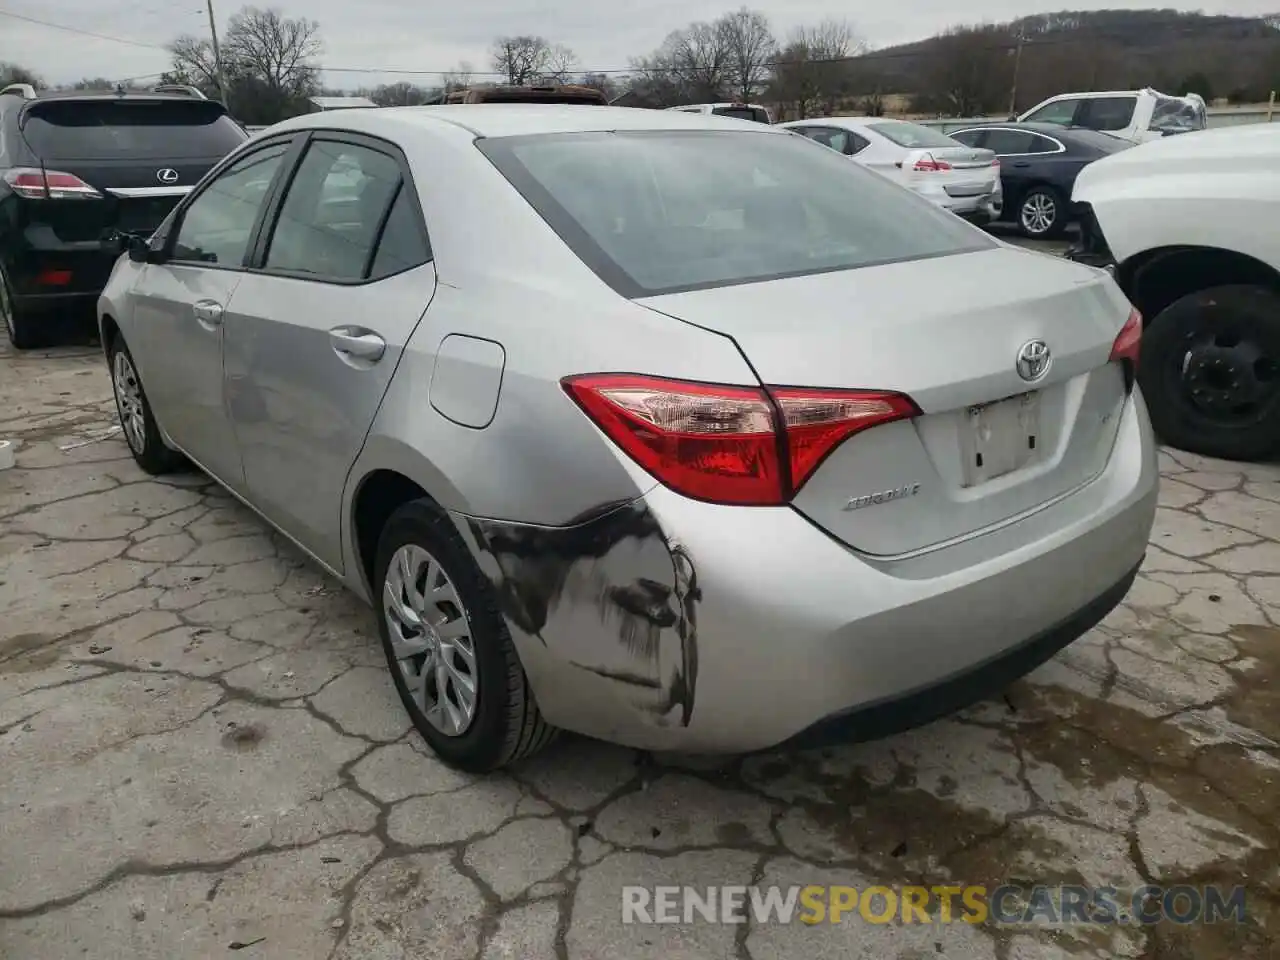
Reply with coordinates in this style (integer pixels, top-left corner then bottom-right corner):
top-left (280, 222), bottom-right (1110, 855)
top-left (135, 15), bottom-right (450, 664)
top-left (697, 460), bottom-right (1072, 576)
top-left (383, 544), bottom-right (480, 737)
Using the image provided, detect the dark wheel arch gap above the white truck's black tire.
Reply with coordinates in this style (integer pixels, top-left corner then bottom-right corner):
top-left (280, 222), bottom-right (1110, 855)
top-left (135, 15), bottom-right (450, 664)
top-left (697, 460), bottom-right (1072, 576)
top-left (1116, 244), bottom-right (1280, 324)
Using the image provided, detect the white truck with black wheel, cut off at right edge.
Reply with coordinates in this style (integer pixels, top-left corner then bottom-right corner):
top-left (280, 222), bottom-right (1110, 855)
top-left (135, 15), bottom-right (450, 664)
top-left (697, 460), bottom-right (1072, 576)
top-left (1066, 123), bottom-right (1280, 461)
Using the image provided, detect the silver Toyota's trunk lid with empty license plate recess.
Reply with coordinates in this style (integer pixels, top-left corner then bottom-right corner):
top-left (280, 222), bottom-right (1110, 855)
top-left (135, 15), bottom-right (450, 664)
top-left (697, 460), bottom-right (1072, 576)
top-left (639, 247), bottom-right (1129, 556)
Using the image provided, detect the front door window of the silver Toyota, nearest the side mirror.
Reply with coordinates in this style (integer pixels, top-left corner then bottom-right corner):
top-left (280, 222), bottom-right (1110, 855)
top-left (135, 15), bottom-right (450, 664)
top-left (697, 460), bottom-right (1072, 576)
top-left (173, 143), bottom-right (289, 266)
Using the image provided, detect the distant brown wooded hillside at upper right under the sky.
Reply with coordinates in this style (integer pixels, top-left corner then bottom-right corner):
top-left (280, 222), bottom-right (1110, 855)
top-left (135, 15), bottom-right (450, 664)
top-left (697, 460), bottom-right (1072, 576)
top-left (856, 10), bottom-right (1280, 113)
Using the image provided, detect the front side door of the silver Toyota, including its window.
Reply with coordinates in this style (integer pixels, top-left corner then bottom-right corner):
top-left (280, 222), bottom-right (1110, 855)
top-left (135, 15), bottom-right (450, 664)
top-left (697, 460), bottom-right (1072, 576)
top-left (134, 143), bottom-right (288, 490)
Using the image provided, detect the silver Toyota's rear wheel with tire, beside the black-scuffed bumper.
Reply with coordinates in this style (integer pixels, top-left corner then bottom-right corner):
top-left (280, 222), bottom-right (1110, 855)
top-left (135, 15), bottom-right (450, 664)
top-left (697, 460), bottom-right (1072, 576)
top-left (372, 500), bottom-right (556, 773)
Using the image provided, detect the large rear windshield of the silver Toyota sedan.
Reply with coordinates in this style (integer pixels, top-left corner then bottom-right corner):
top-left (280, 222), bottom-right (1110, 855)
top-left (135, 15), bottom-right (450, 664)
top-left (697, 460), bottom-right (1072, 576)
top-left (476, 131), bottom-right (993, 297)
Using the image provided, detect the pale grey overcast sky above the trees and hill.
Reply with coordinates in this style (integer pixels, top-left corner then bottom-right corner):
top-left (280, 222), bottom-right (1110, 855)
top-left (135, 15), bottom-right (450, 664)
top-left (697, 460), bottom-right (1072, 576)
top-left (0, 0), bottom-right (1276, 87)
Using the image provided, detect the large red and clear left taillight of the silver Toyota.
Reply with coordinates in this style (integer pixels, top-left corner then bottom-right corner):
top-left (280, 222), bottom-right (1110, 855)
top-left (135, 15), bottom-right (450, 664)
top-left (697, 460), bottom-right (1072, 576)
top-left (563, 374), bottom-right (919, 506)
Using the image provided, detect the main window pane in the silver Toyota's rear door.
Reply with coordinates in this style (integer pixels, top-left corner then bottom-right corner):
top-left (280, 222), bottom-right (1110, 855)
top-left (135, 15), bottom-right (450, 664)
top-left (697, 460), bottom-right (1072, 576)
top-left (265, 140), bottom-right (401, 280)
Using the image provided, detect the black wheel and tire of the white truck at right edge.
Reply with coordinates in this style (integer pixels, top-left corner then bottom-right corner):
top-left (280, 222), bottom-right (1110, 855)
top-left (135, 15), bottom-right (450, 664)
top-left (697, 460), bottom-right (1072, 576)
top-left (1138, 284), bottom-right (1280, 461)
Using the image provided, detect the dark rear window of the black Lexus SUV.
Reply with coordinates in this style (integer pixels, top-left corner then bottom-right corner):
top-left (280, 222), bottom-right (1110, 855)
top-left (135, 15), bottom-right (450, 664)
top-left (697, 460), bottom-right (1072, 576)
top-left (23, 100), bottom-right (247, 160)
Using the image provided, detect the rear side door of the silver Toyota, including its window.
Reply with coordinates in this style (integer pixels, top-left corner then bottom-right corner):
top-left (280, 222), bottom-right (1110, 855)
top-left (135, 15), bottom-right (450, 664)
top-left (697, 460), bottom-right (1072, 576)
top-left (225, 133), bottom-right (435, 570)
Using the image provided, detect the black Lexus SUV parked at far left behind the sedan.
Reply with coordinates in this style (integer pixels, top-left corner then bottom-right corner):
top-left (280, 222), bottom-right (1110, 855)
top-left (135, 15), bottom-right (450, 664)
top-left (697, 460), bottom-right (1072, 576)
top-left (0, 83), bottom-right (248, 348)
